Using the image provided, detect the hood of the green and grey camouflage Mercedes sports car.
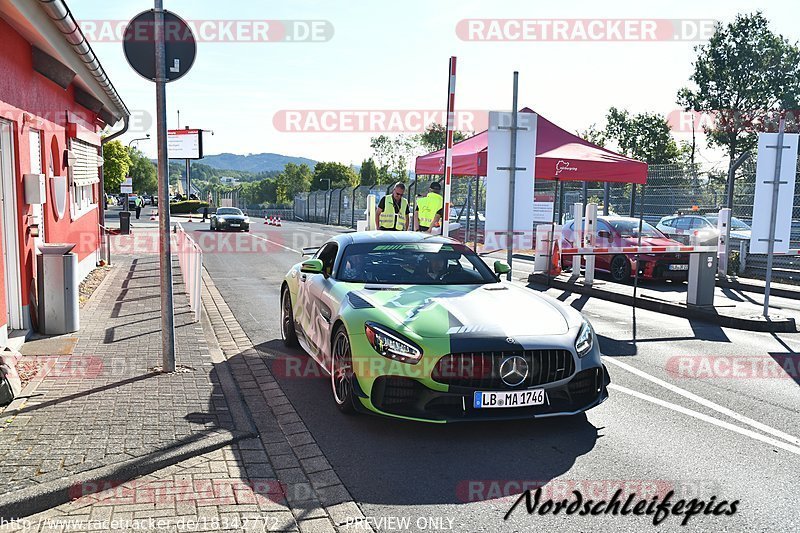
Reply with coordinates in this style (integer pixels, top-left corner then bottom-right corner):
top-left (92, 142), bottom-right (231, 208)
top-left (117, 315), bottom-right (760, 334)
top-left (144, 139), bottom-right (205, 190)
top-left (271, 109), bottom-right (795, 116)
top-left (346, 283), bottom-right (579, 338)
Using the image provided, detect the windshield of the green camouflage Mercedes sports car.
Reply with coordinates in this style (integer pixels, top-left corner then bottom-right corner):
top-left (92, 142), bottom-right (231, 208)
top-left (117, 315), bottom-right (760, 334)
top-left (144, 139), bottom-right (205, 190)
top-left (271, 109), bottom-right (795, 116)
top-left (337, 243), bottom-right (497, 285)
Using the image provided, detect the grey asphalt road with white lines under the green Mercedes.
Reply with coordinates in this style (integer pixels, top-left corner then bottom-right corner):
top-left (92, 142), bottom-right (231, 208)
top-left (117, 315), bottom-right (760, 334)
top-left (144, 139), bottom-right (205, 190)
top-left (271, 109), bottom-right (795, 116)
top-left (184, 218), bottom-right (800, 531)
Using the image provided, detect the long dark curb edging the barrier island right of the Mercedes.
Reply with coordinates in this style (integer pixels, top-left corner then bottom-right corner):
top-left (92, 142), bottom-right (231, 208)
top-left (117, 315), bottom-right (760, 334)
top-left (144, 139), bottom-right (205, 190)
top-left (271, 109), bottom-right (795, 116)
top-left (528, 274), bottom-right (797, 333)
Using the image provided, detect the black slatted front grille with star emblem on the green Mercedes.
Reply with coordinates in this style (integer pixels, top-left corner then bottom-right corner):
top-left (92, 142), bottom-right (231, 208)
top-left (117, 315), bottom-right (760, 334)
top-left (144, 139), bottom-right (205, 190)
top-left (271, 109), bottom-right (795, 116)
top-left (431, 350), bottom-right (575, 390)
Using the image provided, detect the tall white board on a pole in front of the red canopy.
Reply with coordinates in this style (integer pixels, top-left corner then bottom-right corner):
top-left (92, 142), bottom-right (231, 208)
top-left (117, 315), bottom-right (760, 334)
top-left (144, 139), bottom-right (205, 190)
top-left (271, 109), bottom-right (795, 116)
top-left (484, 111), bottom-right (538, 250)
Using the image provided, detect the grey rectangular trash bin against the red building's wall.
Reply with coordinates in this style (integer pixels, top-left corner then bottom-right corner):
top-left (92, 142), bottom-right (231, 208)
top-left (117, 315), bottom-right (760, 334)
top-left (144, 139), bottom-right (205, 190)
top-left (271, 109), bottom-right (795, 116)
top-left (36, 243), bottom-right (80, 335)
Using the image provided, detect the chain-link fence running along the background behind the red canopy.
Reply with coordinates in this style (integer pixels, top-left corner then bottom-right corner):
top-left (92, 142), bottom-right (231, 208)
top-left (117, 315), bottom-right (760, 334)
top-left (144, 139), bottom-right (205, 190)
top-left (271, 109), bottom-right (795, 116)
top-left (294, 159), bottom-right (800, 248)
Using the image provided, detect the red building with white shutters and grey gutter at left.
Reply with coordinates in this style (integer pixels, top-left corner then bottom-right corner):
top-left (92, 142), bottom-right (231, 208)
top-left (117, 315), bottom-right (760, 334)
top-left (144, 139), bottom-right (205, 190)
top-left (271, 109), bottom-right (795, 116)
top-left (0, 0), bottom-right (130, 346)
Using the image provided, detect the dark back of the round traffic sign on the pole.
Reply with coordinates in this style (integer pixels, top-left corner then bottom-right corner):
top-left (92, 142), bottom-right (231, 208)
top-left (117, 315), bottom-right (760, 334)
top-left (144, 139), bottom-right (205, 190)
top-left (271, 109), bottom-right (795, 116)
top-left (122, 9), bottom-right (197, 81)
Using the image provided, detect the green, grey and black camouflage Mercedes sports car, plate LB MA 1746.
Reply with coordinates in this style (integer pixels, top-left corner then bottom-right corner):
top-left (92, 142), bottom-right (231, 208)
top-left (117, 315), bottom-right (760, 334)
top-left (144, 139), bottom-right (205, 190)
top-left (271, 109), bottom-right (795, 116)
top-left (281, 232), bottom-right (609, 422)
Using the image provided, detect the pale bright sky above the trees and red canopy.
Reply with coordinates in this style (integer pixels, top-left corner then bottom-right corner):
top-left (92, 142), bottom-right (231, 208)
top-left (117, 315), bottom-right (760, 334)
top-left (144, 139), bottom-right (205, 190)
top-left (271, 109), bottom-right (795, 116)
top-left (76, 0), bottom-right (800, 168)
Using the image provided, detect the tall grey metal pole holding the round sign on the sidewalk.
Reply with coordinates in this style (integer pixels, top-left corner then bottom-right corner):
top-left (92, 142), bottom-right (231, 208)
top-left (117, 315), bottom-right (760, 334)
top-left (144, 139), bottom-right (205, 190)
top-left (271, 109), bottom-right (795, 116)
top-left (155, 0), bottom-right (175, 372)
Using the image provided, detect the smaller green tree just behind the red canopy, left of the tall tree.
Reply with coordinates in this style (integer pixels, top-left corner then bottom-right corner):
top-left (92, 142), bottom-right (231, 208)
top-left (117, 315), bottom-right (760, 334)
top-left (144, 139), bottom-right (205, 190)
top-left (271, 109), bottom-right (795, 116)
top-left (604, 107), bottom-right (680, 164)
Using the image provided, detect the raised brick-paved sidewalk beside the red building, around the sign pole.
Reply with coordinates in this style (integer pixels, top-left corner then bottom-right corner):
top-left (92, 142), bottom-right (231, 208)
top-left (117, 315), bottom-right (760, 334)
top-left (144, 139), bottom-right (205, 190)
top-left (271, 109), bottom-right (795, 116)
top-left (0, 254), bottom-right (234, 494)
